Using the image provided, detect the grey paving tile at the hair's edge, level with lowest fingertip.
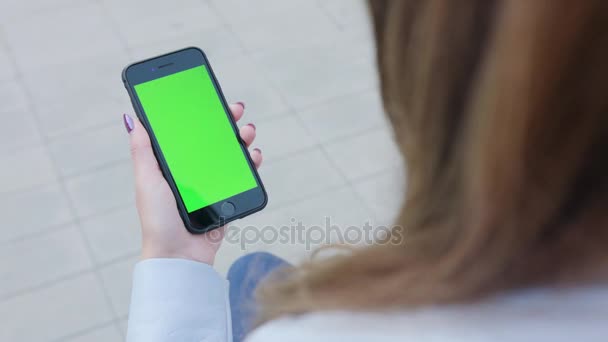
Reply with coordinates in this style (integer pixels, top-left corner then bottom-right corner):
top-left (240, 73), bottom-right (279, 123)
top-left (325, 128), bottom-right (402, 181)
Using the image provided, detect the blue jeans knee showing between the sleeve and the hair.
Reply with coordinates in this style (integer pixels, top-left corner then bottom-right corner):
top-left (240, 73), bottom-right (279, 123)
top-left (228, 252), bottom-right (289, 342)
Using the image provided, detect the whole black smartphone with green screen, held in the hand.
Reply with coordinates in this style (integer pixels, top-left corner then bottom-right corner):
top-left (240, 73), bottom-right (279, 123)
top-left (122, 47), bottom-right (268, 233)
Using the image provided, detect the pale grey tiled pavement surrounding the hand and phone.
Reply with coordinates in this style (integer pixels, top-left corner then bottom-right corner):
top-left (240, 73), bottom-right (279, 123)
top-left (0, 0), bottom-right (403, 342)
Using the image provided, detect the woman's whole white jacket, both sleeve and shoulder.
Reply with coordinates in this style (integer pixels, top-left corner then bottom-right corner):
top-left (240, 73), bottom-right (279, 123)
top-left (127, 259), bottom-right (608, 342)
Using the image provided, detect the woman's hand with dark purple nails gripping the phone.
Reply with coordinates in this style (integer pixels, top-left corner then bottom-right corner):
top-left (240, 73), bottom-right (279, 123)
top-left (124, 102), bottom-right (262, 265)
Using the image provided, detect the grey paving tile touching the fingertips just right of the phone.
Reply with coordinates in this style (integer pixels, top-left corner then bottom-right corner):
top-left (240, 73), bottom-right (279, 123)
top-left (253, 115), bottom-right (315, 161)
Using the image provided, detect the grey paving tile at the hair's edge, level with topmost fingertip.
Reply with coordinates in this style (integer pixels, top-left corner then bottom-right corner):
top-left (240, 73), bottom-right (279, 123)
top-left (298, 90), bottom-right (386, 142)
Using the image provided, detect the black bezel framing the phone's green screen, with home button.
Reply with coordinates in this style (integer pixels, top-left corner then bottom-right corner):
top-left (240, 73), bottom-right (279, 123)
top-left (122, 47), bottom-right (268, 234)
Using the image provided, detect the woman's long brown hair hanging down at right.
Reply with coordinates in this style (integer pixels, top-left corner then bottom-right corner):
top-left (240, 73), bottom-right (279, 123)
top-left (258, 0), bottom-right (608, 320)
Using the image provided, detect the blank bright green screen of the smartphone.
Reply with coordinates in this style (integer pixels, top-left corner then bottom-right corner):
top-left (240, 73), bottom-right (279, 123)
top-left (135, 66), bottom-right (257, 213)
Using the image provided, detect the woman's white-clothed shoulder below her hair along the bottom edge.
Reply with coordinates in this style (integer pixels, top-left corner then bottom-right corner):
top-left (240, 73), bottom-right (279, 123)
top-left (248, 287), bottom-right (608, 342)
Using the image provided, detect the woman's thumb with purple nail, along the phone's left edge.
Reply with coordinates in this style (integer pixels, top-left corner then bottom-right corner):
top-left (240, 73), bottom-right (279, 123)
top-left (123, 114), bottom-right (162, 184)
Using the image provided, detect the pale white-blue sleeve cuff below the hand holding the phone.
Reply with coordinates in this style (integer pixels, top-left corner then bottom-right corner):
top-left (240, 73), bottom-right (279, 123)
top-left (127, 259), bottom-right (232, 342)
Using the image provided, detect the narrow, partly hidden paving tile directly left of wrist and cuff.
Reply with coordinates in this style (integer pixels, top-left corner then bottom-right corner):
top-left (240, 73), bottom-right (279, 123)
top-left (100, 257), bottom-right (139, 317)
